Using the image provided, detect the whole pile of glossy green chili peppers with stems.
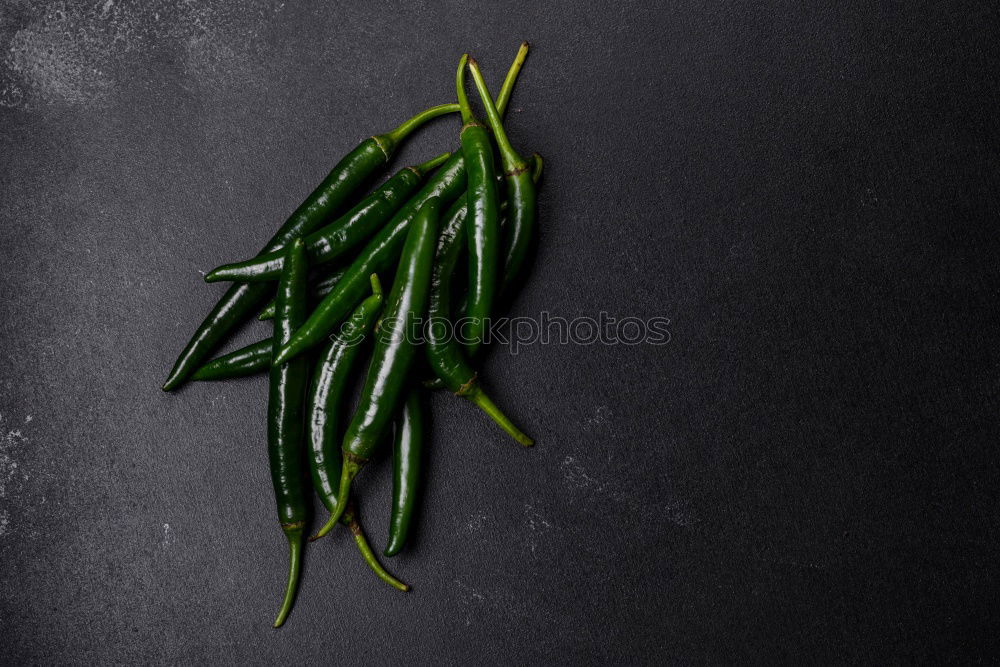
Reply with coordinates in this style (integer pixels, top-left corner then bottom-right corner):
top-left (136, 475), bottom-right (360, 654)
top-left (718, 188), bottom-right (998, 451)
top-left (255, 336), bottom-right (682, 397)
top-left (163, 43), bottom-right (542, 627)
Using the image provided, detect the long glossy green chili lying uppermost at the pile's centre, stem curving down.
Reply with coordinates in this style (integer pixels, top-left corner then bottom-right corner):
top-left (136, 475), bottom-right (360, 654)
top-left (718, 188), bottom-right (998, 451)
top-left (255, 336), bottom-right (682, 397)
top-left (327, 197), bottom-right (440, 536)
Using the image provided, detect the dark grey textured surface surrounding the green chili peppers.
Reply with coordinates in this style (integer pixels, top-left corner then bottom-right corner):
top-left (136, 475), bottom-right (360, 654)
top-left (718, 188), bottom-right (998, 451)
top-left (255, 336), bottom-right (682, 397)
top-left (0, 0), bottom-right (1000, 664)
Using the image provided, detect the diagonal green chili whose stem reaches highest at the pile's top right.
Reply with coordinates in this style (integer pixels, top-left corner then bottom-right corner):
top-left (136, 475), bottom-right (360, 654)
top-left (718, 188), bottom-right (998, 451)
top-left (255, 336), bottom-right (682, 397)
top-left (277, 44), bottom-right (526, 363)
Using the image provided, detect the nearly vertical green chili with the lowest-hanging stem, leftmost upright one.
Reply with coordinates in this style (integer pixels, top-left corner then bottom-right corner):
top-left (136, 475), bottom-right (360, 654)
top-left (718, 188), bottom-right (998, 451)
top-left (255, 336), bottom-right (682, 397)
top-left (267, 239), bottom-right (309, 627)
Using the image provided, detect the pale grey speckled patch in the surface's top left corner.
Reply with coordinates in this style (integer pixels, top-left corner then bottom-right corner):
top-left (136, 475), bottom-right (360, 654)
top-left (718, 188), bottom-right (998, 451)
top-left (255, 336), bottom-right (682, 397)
top-left (0, 0), bottom-right (280, 109)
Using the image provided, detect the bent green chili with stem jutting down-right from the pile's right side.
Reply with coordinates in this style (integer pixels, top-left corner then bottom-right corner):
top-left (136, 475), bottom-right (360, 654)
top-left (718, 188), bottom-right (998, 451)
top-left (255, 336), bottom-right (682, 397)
top-left (425, 196), bottom-right (534, 446)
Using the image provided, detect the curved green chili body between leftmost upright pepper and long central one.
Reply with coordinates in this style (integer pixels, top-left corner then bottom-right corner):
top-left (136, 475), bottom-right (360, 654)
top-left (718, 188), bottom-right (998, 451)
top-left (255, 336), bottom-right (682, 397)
top-left (306, 274), bottom-right (385, 537)
